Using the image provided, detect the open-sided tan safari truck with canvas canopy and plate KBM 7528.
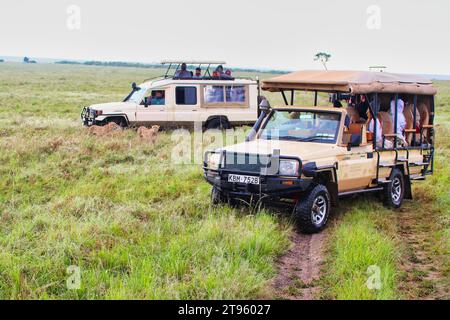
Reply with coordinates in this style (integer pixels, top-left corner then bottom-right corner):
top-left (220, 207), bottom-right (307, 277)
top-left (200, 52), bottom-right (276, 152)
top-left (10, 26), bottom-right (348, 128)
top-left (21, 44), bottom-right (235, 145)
top-left (204, 71), bottom-right (436, 233)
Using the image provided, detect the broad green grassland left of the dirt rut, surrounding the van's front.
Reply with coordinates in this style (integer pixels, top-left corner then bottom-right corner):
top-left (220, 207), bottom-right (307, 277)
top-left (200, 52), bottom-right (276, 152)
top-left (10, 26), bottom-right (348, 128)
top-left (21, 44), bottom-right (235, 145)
top-left (0, 64), bottom-right (289, 299)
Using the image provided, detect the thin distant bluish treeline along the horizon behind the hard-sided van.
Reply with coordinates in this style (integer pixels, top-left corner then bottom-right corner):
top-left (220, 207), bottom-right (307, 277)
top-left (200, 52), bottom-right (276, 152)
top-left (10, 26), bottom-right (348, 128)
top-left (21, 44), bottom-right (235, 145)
top-left (55, 60), bottom-right (288, 74)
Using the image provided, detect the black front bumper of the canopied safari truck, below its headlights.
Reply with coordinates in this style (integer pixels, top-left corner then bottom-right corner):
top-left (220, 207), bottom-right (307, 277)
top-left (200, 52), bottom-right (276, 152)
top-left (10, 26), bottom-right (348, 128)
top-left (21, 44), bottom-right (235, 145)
top-left (204, 168), bottom-right (312, 198)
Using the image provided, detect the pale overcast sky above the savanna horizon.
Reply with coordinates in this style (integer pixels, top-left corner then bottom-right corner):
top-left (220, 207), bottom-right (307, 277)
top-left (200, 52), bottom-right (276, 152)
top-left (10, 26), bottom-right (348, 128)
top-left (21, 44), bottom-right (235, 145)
top-left (0, 0), bottom-right (450, 74)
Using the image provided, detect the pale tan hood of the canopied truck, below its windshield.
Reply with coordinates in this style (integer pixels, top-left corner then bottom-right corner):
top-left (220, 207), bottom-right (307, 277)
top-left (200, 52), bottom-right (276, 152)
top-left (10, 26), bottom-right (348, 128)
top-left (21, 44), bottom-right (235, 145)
top-left (218, 139), bottom-right (338, 162)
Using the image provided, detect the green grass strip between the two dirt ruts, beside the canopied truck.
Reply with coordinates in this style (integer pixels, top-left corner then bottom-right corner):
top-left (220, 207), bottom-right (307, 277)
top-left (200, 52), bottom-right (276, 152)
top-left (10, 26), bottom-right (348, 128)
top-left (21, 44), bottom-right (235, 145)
top-left (322, 199), bottom-right (398, 300)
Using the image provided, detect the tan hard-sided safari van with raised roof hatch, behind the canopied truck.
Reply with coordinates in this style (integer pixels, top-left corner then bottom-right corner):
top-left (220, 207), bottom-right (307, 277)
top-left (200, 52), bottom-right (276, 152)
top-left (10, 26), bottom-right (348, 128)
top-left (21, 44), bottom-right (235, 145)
top-left (81, 61), bottom-right (259, 129)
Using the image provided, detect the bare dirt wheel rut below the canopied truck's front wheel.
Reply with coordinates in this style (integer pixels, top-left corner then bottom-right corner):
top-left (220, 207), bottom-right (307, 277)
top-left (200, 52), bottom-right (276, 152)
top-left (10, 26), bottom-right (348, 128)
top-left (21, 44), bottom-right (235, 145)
top-left (273, 230), bottom-right (327, 300)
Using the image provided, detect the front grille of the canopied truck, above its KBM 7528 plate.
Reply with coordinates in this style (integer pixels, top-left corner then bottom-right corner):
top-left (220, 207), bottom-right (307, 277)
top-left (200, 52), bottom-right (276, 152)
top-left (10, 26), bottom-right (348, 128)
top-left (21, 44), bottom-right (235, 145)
top-left (224, 152), bottom-right (271, 174)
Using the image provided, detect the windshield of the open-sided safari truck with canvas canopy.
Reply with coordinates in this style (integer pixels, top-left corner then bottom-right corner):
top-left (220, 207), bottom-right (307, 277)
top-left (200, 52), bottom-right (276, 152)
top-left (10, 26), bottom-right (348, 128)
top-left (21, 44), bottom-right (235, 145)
top-left (260, 110), bottom-right (341, 143)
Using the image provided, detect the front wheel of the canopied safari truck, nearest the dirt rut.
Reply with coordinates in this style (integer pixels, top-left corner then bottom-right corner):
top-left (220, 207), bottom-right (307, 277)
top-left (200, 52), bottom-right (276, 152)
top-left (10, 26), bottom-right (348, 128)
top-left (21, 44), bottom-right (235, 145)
top-left (294, 184), bottom-right (331, 233)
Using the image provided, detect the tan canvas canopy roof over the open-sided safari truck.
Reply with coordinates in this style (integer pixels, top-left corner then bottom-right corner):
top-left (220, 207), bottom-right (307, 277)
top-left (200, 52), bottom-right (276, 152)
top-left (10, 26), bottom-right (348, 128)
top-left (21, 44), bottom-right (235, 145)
top-left (262, 71), bottom-right (436, 95)
